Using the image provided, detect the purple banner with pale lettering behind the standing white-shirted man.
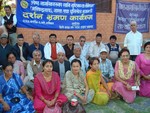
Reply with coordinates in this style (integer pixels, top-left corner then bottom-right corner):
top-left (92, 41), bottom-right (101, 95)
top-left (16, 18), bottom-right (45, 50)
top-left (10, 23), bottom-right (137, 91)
top-left (114, 0), bottom-right (150, 33)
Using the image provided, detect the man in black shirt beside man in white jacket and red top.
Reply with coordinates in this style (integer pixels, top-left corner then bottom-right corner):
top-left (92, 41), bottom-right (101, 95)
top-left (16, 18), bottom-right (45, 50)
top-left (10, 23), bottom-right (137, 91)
top-left (63, 35), bottom-right (74, 59)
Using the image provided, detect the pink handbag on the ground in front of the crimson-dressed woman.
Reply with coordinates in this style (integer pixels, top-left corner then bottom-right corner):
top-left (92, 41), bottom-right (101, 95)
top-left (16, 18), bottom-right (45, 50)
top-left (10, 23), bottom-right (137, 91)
top-left (43, 104), bottom-right (62, 113)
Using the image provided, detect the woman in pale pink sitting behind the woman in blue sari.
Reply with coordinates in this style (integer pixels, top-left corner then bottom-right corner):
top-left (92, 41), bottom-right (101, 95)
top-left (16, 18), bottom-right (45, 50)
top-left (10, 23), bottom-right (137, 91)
top-left (7, 52), bottom-right (25, 80)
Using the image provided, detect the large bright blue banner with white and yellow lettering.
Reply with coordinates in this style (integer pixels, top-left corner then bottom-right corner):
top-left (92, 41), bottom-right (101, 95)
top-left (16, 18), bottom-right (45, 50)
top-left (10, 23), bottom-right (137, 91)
top-left (16, 0), bottom-right (96, 30)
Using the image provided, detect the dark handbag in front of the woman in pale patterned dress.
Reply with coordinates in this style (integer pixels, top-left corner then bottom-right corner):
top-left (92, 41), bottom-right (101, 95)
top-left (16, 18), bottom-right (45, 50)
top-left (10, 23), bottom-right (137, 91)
top-left (62, 102), bottom-right (86, 113)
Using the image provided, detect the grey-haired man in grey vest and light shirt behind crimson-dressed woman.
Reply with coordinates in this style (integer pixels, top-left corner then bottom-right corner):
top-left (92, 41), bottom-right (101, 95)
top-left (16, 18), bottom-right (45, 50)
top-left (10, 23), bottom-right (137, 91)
top-left (24, 49), bottom-right (43, 89)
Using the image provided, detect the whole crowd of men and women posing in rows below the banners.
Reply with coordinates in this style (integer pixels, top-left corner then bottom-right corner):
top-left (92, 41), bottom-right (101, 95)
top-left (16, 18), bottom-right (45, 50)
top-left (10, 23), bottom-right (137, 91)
top-left (0, 6), bottom-right (150, 113)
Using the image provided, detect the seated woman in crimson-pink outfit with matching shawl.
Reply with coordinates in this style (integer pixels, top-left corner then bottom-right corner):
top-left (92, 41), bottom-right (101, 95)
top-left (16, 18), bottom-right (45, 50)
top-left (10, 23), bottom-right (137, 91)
top-left (34, 60), bottom-right (67, 113)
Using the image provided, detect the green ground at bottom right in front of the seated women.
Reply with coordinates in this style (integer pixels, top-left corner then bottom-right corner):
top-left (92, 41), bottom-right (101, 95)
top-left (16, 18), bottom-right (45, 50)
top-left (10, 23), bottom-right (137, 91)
top-left (85, 97), bottom-right (150, 113)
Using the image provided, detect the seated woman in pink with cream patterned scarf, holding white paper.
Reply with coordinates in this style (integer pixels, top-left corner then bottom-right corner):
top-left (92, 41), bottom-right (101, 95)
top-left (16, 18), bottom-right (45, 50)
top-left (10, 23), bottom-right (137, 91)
top-left (112, 48), bottom-right (140, 103)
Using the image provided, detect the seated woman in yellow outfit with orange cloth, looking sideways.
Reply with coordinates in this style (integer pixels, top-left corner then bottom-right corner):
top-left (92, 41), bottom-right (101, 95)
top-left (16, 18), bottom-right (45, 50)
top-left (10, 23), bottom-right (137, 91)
top-left (86, 57), bottom-right (113, 105)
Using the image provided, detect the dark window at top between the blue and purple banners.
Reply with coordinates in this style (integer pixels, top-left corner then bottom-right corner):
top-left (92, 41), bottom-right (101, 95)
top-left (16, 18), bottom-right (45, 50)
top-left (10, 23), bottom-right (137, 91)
top-left (76, 0), bottom-right (112, 13)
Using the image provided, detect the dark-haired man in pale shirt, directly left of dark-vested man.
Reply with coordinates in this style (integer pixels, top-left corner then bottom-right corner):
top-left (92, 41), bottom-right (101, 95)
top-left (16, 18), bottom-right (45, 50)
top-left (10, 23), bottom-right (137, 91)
top-left (89, 33), bottom-right (106, 57)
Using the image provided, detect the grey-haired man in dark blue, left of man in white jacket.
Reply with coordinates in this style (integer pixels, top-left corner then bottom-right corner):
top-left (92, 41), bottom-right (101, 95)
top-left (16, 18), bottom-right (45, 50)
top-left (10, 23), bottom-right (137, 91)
top-left (28, 32), bottom-right (44, 60)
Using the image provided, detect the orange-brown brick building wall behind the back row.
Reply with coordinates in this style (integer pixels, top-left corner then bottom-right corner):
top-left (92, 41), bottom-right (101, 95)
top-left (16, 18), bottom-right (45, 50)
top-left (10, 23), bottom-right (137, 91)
top-left (17, 0), bottom-right (150, 44)
